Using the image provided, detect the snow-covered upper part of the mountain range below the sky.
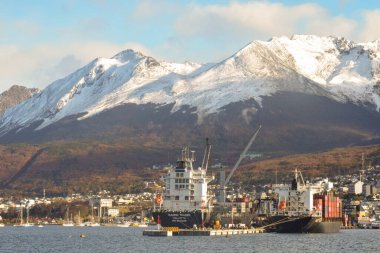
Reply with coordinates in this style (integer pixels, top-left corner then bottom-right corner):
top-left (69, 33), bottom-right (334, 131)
top-left (0, 35), bottom-right (380, 135)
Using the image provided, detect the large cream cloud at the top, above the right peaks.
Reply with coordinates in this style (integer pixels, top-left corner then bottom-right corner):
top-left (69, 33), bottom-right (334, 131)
top-left (176, 1), bottom-right (356, 40)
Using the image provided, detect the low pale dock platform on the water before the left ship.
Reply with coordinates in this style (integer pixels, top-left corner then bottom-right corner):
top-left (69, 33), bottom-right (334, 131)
top-left (143, 228), bottom-right (264, 237)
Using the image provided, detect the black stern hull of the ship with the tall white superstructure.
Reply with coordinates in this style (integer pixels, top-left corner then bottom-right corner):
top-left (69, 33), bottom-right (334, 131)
top-left (153, 211), bottom-right (206, 229)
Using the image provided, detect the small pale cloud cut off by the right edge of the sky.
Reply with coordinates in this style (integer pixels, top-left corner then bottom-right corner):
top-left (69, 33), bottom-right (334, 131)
top-left (359, 10), bottom-right (380, 42)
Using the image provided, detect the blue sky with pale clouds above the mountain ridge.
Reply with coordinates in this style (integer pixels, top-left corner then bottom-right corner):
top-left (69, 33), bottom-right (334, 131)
top-left (0, 0), bottom-right (380, 92)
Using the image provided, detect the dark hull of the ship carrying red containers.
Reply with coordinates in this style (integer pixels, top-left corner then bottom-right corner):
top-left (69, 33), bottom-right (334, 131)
top-left (271, 216), bottom-right (342, 233)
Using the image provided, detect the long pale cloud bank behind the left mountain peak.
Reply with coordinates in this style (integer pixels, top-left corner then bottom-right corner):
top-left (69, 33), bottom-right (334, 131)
top-left (0, 42), bottom-right (150, 91)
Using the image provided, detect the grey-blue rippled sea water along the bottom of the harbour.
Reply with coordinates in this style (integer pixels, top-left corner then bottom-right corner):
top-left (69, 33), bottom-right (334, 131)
top-left (0, 226), bottom-right (380, 253)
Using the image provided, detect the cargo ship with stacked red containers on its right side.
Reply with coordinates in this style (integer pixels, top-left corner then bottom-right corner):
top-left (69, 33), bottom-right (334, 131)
top-left (267, 169), bottom-right (342, 233)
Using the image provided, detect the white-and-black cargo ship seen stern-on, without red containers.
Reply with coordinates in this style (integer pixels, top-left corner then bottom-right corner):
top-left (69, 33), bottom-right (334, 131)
top-left (152, 143), bottom-right (213, 229)
